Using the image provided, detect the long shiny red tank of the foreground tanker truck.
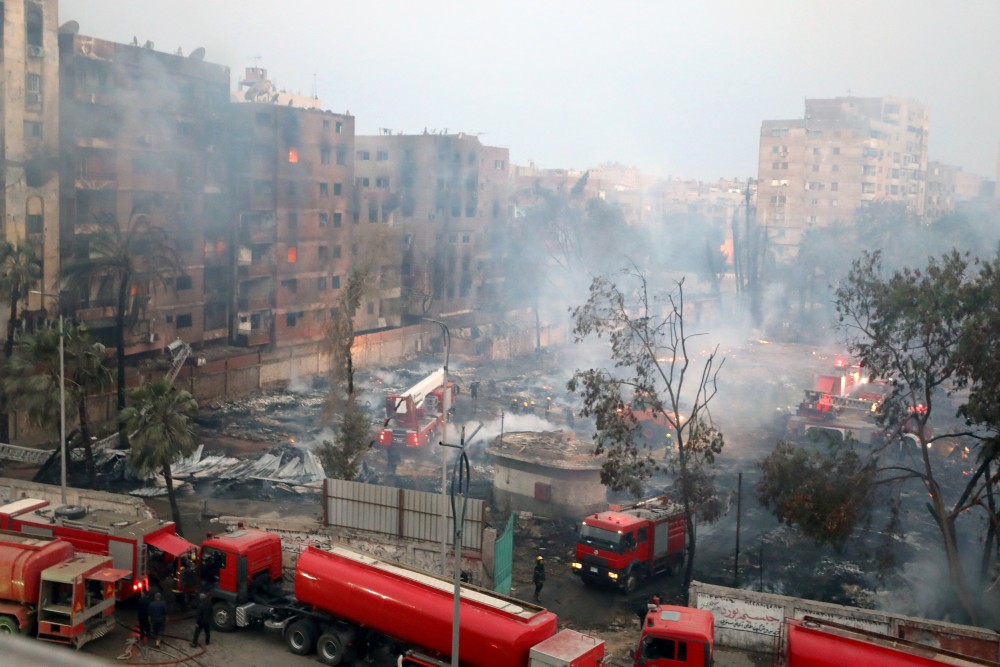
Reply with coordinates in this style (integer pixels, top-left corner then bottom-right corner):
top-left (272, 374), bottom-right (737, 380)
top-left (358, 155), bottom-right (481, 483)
top-left (295, 546), bottom-right (558, 667)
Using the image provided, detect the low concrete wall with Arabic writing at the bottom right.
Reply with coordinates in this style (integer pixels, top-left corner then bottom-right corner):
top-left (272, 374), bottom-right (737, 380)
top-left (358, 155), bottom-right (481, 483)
top-left (688, 581), bottom-right (1000, 660)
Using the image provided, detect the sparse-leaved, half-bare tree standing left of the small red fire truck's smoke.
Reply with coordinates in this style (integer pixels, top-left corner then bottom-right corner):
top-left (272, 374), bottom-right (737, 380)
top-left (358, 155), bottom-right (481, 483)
top-left (568, 266), bottom-right (725, 588)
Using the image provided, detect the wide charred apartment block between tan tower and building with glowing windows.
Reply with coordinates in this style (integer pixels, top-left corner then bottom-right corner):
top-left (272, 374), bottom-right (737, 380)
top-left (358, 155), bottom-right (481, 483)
top-left (59, 29), bottom-right (231, 355)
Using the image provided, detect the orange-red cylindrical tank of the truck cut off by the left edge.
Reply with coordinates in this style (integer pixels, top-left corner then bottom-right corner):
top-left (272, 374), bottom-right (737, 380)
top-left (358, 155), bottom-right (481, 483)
top-left (0, 533), bottom-right (73, 605)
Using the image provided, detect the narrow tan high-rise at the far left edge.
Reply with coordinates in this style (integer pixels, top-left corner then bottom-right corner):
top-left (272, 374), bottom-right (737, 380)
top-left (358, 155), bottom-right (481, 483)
top-left (0, 0), bottom-right (59, 318)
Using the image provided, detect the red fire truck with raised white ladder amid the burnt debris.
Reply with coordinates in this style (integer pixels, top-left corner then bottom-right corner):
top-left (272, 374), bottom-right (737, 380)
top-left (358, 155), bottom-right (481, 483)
top-left (378, 368), bottom-right (457, 447)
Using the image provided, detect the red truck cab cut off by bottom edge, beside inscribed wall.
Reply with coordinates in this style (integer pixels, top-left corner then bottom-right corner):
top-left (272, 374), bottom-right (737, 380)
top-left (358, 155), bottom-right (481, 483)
top-left (633, 605), bottom-right (715, 667)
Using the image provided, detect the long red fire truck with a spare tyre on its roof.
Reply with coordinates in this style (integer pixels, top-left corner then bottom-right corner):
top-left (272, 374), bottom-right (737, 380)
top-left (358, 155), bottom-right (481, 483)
top-left (0, 498), bottom-right (197, 600)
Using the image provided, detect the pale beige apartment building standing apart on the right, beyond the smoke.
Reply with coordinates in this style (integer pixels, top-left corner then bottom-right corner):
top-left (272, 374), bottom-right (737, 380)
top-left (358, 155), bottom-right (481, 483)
top-left (757, 97), bottom-right (929, 257)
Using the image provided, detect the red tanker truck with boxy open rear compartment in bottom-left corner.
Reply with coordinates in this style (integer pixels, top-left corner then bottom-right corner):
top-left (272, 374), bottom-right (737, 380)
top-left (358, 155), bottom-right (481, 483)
top-left (0, 531), bottom-right (128, 648)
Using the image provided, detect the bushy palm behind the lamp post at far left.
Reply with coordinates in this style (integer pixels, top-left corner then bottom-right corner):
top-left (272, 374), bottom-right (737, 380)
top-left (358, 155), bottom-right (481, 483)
top-left (3, 323), bottom-right (111, 478)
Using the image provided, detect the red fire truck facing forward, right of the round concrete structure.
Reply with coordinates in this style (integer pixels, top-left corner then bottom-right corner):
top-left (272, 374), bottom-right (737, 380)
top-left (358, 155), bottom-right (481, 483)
top-left (571, 496), bottom-right (688, 593)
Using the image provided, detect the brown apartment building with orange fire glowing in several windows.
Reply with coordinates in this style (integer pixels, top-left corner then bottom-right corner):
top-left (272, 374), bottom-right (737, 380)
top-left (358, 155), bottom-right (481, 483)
top-left (227, 101), bottom-right (363, 347)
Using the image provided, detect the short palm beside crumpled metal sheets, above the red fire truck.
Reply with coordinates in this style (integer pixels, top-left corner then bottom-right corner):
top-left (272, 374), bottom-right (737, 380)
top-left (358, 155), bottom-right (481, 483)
top-left (120, 379), bottom-right (198, 533)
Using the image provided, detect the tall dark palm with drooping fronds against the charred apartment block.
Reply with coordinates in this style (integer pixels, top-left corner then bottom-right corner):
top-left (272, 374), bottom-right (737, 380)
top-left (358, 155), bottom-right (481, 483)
top-left (62, 213), bottom-right (180, 420)
